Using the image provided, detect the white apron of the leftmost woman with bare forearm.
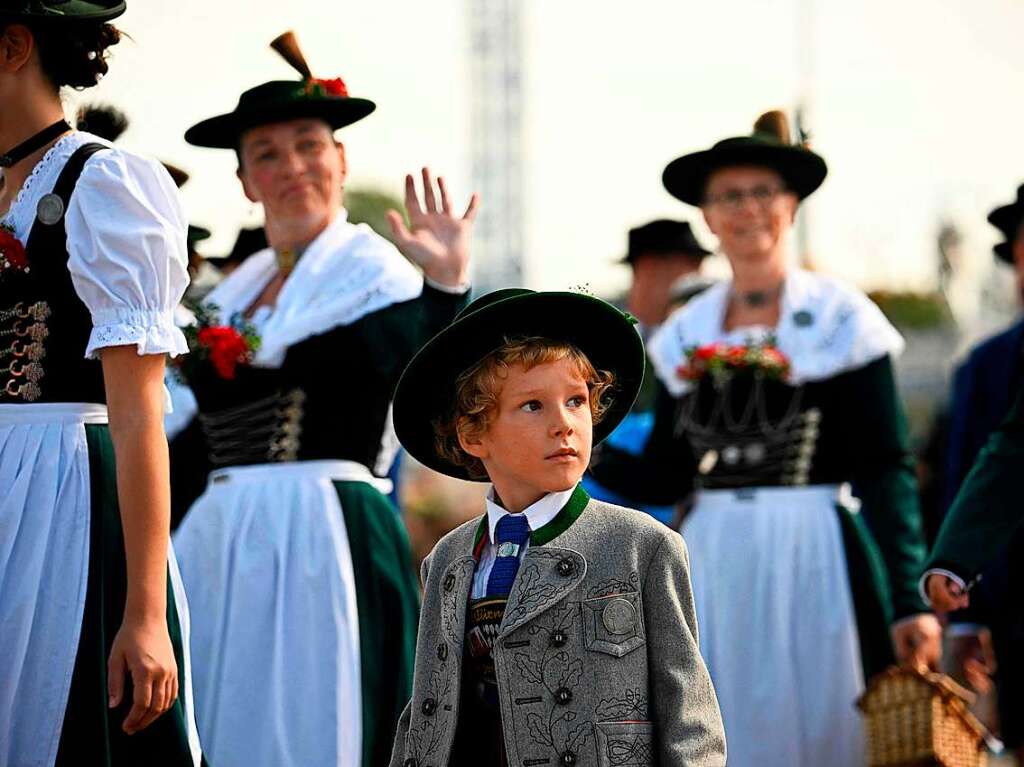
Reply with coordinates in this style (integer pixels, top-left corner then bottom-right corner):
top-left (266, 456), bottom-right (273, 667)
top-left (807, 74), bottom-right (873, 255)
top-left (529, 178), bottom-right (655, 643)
top-left (0, 402), bottom-right (200, 767)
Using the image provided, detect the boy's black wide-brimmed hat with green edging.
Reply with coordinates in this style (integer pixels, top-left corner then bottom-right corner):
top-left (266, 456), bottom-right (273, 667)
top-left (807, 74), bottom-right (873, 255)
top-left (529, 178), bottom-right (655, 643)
top-left (392, 288), bottom-right (644, 481)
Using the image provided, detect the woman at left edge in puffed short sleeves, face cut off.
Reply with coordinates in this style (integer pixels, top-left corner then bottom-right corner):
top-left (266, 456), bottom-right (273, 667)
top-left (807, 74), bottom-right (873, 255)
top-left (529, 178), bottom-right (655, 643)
top-left (0, 0), bottom-right (201, 766)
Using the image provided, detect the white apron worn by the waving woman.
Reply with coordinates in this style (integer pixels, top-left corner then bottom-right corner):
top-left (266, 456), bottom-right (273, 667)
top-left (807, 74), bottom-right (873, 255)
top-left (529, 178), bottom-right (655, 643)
top-left (174, 461), bottom-right (390, 767)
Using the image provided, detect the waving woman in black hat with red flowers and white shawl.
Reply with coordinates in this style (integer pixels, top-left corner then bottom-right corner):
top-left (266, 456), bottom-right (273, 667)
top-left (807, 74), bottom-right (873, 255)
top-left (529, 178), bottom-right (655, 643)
top-left (175, 36), bottom-right (476, 767)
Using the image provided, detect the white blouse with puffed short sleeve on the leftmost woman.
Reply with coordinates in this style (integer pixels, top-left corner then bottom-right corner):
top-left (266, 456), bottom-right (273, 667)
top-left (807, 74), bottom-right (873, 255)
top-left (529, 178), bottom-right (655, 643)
top-left (0, 132), bottom-right (188, 357)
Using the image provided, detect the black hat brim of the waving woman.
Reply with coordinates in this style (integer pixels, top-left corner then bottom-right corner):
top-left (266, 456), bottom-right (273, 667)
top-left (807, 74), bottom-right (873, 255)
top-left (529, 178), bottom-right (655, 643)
top-left (185, 97), bottom-right (377, 150)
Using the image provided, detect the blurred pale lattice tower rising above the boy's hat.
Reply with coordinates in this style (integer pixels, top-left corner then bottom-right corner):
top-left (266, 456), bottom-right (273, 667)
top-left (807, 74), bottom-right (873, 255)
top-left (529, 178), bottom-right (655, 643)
top-left (466, 0), bottom-right (524, 292)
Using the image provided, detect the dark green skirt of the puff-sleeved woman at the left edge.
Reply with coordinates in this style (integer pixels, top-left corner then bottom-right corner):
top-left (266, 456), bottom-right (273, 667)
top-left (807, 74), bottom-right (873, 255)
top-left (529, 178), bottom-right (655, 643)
top-left (56, 425), bottom-right (201, 767)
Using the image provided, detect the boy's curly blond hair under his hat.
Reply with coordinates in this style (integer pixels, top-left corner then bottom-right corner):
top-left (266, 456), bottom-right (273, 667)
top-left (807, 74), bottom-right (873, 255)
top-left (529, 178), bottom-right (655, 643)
top-left (434, 336), bottom-right (614, 479)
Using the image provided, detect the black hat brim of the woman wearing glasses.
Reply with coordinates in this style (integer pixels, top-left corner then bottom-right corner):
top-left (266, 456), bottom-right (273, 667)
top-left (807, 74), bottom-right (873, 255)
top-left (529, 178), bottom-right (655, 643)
top-left (662, 143), bottom-right (828, 207)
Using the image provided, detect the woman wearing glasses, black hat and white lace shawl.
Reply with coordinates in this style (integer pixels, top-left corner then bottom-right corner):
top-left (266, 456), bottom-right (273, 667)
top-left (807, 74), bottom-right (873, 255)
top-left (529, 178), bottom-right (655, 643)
top-left (594, 113), bottom-right (940, 767)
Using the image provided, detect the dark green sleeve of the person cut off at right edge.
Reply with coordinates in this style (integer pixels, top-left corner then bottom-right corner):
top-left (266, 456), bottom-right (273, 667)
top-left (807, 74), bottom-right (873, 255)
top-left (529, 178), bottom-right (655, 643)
top-left (926, 390), bottom-right (1024, 582)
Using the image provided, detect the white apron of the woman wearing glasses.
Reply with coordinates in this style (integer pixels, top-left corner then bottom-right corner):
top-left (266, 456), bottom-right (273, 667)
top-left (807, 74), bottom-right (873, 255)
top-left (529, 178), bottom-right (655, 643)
top-left (681, 485), bottom-right (864, 767)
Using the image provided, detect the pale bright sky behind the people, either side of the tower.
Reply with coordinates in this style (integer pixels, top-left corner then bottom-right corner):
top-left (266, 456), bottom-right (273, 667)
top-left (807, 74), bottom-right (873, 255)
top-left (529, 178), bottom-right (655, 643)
top-left (69, 0), bottom-right (1024, 292)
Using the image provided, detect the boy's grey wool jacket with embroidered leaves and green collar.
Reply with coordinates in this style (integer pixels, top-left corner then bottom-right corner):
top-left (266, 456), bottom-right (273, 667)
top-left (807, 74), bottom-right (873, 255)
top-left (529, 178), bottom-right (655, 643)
top-left (391, 487), bottom-right (725, 767)
